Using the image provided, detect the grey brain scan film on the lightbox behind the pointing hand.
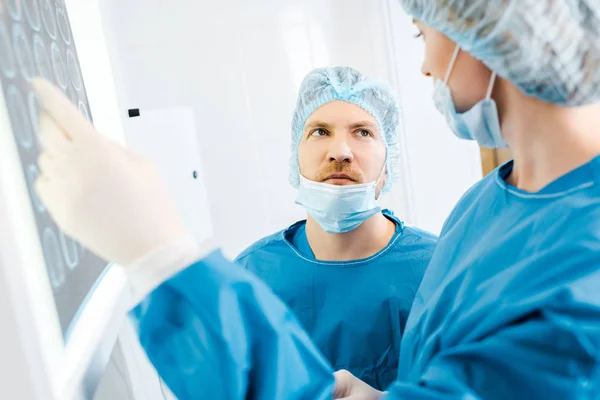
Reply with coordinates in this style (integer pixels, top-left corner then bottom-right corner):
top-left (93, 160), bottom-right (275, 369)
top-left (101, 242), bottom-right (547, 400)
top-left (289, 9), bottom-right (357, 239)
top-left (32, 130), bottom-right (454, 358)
top-left (0, 0), bottom-right (108, 340)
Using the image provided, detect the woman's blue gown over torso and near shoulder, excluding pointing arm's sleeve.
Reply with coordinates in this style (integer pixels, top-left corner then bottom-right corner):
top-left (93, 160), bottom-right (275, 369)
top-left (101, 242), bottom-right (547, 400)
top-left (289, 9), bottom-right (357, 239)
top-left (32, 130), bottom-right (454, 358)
top-left (391, 157), bottom-right (600, 399)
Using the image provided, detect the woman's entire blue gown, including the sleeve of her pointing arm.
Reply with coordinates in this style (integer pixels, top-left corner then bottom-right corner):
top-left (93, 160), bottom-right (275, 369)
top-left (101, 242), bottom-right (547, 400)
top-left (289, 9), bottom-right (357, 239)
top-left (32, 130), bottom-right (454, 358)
top-left (133, 157), bottom-right (600, 399)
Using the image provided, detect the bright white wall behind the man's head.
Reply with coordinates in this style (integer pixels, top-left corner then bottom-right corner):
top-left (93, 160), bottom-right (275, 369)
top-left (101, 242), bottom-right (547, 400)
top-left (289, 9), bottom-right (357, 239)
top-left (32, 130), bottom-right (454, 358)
top-left (100, 0), bottom-right (480, 256)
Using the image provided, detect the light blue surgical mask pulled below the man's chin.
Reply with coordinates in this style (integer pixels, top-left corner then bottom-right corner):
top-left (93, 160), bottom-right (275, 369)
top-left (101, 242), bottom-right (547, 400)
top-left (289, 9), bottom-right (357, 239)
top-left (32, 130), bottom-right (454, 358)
top-left (296, 166), bottom-right (385, 233)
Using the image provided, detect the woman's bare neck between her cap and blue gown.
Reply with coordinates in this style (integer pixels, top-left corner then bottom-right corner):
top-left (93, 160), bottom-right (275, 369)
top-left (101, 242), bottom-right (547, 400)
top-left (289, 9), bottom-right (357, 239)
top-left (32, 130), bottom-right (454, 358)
top-left (497, 82), bottom-right (600, 192)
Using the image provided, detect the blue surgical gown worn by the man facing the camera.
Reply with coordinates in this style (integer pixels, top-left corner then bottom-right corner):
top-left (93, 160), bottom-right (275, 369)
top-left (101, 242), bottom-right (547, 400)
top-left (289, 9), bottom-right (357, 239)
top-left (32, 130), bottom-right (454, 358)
top-left (236, 210), bottom-right (437, 390)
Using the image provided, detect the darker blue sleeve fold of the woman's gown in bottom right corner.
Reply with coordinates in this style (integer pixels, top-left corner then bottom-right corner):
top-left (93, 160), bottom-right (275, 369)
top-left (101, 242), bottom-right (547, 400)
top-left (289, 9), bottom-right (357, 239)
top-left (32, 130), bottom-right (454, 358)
top-left (389, 306), bottom-right (600, 400)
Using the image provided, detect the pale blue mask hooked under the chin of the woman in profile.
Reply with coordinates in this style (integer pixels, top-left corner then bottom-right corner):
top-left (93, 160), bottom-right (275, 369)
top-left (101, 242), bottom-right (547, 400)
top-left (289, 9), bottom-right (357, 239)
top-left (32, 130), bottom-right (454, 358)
top-left (433, 46), bottom-right (508, 149)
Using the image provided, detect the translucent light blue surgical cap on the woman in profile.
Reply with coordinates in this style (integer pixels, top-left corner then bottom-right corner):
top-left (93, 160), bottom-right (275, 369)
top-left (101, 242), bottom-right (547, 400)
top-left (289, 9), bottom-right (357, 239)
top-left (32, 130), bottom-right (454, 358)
top-left (400, 0), bottom-right (600, 106)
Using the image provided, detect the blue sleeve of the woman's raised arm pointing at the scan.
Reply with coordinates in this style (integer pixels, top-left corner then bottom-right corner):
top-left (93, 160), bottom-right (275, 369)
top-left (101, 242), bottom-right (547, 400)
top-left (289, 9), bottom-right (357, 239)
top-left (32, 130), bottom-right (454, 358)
top-left (131, 248), bottom-right (334, 400)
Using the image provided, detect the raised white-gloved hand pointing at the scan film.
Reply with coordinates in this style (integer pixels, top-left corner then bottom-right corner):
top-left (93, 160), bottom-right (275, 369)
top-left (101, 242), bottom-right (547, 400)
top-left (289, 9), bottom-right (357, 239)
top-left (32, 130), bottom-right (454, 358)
top-left (32, 79), bottom-right (190, 267)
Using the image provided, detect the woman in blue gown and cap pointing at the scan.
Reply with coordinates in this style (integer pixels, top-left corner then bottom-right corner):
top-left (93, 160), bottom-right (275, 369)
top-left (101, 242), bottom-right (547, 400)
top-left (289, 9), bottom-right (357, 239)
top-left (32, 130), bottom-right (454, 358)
top-left (33, 0), bottom-right (600, 399)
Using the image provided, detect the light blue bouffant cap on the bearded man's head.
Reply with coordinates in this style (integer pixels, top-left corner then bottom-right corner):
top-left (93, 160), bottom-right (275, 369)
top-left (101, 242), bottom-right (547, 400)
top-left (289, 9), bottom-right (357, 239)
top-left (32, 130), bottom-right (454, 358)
top-left (290, 67), bottom-right (402, 191)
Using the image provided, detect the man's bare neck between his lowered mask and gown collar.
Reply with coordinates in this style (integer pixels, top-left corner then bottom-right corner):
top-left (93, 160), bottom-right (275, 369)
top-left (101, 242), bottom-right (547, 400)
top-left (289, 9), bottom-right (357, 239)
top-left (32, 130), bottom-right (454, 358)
top-left (306, 213), bottom-right (396, 261)
